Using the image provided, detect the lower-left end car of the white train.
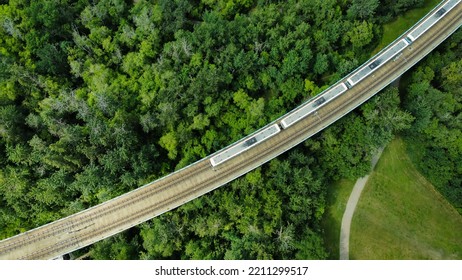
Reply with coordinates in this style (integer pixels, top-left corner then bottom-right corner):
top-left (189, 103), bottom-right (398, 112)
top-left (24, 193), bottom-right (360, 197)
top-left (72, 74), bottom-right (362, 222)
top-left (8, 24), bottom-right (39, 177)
top-left (210, 124), bottom-right (281, 167)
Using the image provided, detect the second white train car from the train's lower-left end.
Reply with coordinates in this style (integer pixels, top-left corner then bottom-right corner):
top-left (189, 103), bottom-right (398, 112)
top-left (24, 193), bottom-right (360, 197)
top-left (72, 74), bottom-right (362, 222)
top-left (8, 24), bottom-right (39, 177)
top-left (281, 83), bottom-right (348, 129)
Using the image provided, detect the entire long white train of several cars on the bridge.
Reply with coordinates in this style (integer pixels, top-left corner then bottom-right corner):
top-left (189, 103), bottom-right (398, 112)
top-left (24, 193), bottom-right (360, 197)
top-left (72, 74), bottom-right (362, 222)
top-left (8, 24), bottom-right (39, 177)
top-left (210, 0), bottom-right (462, 167)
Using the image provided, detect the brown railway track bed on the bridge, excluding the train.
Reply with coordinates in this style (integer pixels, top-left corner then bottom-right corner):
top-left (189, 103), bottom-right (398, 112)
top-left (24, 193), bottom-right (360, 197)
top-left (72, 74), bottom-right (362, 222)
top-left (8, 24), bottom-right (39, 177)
top-left (0, 0), bottom-right (462, 259)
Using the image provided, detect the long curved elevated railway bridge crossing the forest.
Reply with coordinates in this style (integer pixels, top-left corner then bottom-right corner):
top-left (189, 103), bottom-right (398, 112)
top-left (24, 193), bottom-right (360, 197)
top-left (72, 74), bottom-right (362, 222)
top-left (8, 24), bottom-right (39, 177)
top-left (0, 0), bottom-right (462, 259)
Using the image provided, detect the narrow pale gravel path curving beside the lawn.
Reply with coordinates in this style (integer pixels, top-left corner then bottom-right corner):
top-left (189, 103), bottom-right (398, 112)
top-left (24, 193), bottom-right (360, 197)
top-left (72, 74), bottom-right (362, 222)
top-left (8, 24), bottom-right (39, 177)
top-left (340, 148), bottom-right (383, 260)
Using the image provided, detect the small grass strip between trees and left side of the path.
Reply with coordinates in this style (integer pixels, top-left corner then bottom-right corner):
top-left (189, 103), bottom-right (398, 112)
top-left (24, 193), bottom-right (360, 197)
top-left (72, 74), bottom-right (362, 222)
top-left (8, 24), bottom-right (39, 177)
top-left (322, 179), bottom-right (355, 260)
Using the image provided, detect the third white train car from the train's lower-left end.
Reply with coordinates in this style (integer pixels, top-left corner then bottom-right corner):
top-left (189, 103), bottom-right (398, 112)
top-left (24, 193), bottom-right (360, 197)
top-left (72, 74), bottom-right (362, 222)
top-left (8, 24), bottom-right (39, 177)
top-left (347, 39), bottom-right (409, 88)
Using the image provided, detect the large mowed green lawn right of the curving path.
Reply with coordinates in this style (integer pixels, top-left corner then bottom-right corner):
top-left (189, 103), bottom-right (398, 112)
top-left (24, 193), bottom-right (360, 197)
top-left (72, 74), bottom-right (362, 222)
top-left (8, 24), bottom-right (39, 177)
top-left (350, 138), bottom-right (462, 259)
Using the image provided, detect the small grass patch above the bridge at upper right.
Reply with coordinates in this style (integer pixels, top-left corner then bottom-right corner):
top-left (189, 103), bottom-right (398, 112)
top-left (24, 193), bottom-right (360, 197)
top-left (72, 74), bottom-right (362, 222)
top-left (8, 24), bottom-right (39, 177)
top-left (372, 0), bottom-right (441, 54)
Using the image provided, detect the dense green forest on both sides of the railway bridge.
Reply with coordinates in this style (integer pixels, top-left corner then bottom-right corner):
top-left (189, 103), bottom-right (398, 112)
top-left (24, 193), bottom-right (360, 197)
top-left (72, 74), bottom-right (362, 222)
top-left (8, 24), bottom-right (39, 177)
top-left (0, 0), bottom-right (462, 259)
